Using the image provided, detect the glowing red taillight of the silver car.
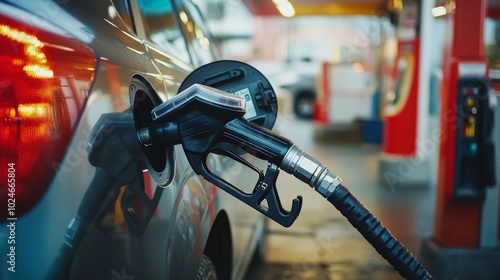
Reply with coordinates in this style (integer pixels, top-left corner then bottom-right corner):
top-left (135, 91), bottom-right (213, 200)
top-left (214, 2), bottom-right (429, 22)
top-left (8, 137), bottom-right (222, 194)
top-left (0, 12), bottom-right (96, 220)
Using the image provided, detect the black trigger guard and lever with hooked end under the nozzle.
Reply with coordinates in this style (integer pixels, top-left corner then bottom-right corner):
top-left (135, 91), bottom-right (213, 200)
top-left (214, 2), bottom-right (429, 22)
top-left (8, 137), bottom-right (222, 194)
top-left (200, 149), bottom-right (302, 227)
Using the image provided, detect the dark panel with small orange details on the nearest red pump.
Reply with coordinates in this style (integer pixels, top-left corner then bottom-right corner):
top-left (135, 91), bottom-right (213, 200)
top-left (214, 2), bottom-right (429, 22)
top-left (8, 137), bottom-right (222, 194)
top-left (453, 77), bottom-right (496, 199)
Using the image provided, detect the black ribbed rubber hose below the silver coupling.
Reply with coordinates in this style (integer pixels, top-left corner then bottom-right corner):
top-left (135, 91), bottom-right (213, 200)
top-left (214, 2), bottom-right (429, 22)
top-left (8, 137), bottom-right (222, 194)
top-left (328, 184), bottom-right (433, 280)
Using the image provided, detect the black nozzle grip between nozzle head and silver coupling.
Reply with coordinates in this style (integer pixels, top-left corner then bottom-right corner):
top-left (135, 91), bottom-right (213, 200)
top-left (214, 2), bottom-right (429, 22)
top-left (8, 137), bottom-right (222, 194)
top-left (220, 118), bottom-right (293, 166)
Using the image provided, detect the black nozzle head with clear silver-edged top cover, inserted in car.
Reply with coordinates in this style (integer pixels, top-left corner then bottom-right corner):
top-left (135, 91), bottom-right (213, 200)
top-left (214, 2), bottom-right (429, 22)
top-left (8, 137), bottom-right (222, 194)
top-left (137, 84), bottom-right (246, 149)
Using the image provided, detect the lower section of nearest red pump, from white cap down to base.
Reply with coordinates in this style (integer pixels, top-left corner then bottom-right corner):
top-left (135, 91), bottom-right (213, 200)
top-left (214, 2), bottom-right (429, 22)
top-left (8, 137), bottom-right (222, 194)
top-left (422, 63), bottom-right (500, 279)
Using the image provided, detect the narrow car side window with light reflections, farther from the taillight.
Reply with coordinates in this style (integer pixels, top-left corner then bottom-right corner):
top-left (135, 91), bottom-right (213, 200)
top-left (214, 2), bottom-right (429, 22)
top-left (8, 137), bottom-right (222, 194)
top-left (175, 0), bottom-right (215, 65)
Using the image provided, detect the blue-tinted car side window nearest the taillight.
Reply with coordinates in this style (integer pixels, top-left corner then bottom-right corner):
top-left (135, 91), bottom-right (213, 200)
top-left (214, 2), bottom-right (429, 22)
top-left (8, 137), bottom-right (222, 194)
top-left (137, 0), bottom-right (191, 63)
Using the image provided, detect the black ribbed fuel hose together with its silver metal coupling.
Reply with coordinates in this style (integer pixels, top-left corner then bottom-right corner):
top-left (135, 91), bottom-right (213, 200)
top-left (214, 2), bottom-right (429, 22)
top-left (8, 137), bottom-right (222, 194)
top-left (281, 145), bottom-right (433, 280)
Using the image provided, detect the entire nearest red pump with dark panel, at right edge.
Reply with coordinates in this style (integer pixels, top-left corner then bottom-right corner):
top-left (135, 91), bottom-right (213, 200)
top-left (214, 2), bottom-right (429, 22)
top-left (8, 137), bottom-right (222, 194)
top-left (422, 0), bottom-right (500, 279)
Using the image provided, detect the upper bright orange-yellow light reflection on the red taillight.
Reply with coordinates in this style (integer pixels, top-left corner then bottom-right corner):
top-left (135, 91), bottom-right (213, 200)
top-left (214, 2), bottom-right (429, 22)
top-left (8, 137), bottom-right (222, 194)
top-left (0, 25), bottom-right (54, 79)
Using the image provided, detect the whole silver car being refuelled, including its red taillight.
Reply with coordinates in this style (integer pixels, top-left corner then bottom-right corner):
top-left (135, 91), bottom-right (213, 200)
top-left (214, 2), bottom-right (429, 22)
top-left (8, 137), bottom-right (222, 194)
top-left (0, 0), bottom-right (266, 280)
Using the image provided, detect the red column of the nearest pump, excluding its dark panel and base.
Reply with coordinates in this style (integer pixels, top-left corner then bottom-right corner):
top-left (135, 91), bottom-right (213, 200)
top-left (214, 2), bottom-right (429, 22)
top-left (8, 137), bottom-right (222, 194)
top-left (434, 0), bottom-right (488, 247)
